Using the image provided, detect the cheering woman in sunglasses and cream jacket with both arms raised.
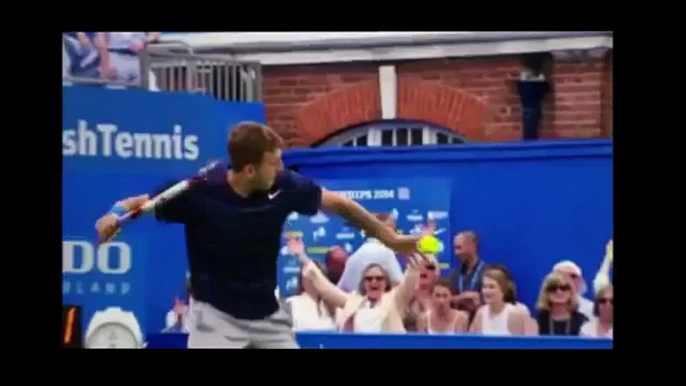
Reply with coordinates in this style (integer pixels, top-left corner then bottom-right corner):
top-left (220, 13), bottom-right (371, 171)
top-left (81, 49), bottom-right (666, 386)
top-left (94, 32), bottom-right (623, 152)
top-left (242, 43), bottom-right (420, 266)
top-left (289, 240), bottom-right (427, 333)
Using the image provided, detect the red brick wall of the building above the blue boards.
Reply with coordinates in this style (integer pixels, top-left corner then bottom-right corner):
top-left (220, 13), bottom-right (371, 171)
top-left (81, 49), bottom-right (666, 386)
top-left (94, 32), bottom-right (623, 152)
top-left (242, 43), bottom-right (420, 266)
top-left (263, 52), bottom-right (612, 146)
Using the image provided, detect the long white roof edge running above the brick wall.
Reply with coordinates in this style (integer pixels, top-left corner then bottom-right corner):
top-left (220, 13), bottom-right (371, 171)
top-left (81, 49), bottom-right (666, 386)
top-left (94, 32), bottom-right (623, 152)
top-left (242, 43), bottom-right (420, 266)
top-left (226, 36), bottom-right (612, 66)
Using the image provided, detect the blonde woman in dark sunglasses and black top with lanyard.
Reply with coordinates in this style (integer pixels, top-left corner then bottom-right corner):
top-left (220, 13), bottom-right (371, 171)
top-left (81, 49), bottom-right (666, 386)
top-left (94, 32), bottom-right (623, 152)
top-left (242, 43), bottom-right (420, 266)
top-left (536, 272), bottom-right (588, 336)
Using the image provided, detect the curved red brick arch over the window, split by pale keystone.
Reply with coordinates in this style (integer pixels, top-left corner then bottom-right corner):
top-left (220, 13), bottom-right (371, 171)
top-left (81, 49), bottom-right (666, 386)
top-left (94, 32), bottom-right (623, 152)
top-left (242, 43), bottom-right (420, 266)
top-left (296, 80), bottom-right (486, 145)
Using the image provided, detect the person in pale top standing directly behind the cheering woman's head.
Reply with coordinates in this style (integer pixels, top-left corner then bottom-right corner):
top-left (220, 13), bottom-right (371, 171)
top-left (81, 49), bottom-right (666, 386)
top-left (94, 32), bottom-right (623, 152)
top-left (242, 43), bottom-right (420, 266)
top-left (338, 213), bottom-right (403, 292)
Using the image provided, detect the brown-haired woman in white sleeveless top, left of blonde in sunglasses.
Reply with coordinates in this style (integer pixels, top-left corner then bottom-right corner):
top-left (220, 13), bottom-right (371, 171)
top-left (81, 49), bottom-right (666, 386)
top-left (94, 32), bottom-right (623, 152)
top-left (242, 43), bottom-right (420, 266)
top-left (469, 268), bottom-right (528, 335)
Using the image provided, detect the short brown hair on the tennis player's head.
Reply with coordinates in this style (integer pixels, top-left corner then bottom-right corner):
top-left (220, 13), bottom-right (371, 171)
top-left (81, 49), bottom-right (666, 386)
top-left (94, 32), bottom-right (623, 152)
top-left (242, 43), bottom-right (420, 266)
top-left (228, 122), bottom-right (283, 172)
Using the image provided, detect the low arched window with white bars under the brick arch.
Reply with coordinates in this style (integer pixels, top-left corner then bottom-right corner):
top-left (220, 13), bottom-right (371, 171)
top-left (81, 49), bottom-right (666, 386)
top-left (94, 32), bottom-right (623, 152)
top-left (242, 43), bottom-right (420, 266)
top-left (315, 119), bottom-right (467, 147)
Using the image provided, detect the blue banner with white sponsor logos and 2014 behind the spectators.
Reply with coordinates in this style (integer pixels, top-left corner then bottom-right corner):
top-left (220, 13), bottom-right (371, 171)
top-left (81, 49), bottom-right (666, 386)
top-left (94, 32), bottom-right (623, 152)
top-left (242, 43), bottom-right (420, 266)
top-left (278, 178), bottom-right (452, 297)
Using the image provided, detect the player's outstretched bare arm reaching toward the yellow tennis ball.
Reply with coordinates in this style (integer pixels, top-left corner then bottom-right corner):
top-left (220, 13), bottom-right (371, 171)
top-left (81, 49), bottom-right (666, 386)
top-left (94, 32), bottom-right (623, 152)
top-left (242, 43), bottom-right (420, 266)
top-left (321, 188), bottom-right (421, 255)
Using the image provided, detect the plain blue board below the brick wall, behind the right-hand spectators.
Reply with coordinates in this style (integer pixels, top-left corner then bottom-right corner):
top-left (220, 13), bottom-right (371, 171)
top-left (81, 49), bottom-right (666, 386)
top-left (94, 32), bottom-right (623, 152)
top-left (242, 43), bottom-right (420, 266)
top-left (284, 140), bottom-right (613, 311)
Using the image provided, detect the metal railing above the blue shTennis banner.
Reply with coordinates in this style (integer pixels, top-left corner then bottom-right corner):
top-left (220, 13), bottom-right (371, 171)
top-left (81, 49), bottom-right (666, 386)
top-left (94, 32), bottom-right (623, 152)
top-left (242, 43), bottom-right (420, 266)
top-left (63, 35), bottom-right (262, 102)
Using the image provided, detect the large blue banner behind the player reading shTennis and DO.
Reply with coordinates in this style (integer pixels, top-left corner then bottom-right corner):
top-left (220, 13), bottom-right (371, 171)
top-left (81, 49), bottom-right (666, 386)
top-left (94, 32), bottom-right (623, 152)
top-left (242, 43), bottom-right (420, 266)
top-left (62, 87), bottom-right (264, 332)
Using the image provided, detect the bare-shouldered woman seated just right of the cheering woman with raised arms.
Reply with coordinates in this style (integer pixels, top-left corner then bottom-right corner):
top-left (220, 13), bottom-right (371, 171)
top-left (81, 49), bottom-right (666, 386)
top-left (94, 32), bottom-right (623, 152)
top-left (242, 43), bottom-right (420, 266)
top-left (417, 279), bottom-right (469, 335)
